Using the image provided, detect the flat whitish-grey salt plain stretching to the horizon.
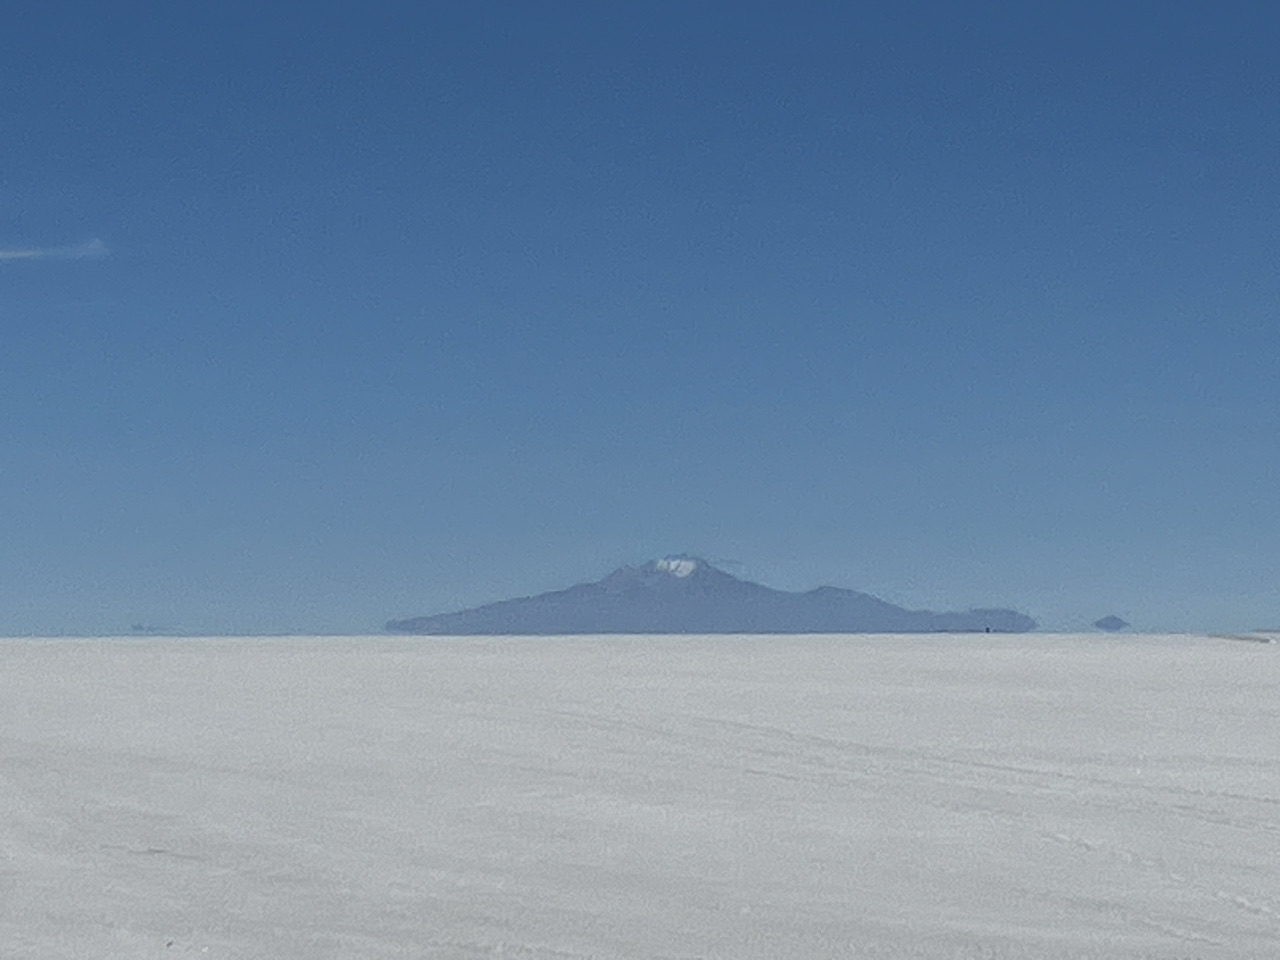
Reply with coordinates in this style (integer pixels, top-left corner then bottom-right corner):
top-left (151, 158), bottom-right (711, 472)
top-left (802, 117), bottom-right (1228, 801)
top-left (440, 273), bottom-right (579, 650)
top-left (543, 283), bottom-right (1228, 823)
top-left (0, 636), bottom-right (1280, 960)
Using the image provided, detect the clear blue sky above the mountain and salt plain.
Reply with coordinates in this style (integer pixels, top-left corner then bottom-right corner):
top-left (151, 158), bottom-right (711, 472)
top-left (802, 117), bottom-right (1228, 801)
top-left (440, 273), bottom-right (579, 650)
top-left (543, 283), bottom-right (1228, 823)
top-left (0, 0), bottom-right (1280, 634)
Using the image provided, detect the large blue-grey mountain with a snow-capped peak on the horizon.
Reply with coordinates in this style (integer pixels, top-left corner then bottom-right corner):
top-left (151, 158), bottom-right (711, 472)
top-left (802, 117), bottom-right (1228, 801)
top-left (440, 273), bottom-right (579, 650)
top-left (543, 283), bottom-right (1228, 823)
top-left (387, 557), bottom-right (1036, 636)
